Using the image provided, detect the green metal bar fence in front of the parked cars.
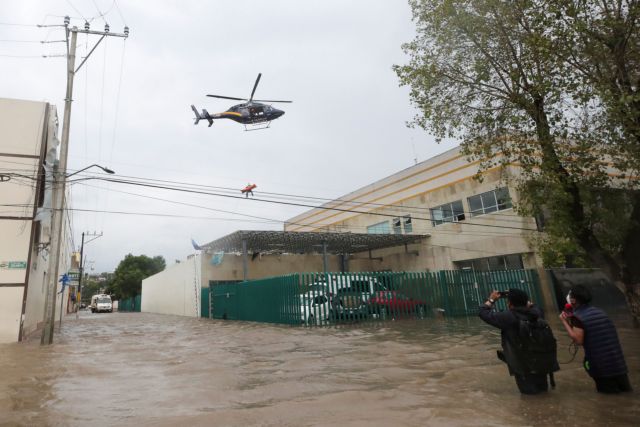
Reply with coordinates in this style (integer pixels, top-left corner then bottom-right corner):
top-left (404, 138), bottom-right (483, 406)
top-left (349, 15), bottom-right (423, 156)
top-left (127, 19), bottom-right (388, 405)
top-left (209, 270), bottom-right (540, 325)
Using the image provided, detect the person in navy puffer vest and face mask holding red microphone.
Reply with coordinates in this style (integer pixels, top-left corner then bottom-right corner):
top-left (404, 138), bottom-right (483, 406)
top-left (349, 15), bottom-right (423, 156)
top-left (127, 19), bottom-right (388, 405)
top-left (560, 285), bottom-right (631, 393)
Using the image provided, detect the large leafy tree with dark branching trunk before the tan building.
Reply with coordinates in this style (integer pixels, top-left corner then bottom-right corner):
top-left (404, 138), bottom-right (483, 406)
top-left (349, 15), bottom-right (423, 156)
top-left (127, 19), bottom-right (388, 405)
top-left (394, 0), bottom-right (640, 320)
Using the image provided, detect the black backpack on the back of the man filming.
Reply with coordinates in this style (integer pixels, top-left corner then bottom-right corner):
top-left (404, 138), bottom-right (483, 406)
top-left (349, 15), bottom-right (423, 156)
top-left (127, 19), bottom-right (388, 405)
top-left (517, 316), bottom-right (560, 374)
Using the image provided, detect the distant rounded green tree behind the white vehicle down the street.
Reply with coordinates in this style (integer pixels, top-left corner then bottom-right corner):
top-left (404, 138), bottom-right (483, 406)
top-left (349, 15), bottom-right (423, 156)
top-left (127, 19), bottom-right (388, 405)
top-left (109, 254), bottom-right (166, 298)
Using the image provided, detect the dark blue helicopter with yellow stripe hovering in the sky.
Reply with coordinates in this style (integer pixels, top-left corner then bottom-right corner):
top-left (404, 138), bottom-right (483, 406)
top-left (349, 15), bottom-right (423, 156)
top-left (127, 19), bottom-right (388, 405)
top-left (191, 73), bottom-right (293, 130)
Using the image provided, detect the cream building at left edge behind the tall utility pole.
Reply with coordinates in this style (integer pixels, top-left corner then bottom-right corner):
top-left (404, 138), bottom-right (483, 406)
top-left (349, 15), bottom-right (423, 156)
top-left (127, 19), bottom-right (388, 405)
top-left (0, 98), bottom-right (72, 343)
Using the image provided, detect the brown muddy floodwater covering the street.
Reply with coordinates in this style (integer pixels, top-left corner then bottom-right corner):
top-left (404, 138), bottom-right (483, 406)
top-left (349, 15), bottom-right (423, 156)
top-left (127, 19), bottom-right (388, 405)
top-left (0, 312), bottom-right (640, 427)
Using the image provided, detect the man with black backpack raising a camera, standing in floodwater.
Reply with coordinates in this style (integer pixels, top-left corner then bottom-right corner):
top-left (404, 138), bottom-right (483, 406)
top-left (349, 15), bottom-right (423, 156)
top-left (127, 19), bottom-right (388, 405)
top-left (478, 289), bottom-right (560, 394)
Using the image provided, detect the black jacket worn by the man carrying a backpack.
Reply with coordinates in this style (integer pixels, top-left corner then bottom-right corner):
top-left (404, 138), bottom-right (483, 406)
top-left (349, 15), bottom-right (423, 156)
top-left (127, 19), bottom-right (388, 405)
top-left (478, 304), bottom-right (544, 375)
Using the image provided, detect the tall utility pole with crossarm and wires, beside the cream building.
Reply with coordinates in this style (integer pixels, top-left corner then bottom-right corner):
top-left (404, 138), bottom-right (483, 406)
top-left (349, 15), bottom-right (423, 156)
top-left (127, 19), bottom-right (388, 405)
top-left (40, 16), bottom-right (129, 345)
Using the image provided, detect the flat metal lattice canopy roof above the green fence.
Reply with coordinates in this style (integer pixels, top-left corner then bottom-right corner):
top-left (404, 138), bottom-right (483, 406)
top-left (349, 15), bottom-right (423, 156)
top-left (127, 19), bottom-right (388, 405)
top-left (202, 230), bottom-right (430, 255)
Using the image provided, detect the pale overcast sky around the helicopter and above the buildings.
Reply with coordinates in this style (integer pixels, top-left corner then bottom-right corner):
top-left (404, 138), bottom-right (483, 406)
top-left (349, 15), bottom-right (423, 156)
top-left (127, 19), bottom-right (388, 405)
top-left (0, 0), bottom-right (454, 273)
